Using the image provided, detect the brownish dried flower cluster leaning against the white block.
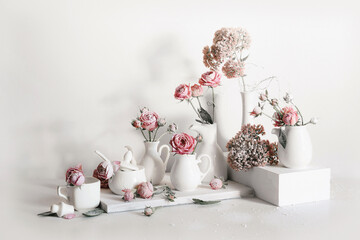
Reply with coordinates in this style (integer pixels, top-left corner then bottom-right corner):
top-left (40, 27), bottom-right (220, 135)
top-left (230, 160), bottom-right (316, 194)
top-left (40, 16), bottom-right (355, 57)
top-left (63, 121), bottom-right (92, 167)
top-left (226, 124), bottom-right (278, 171)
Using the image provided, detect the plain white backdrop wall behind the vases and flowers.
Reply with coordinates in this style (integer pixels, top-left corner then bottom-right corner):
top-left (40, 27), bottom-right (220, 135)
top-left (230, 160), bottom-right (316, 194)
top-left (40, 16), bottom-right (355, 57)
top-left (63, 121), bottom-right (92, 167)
top-left (0, 0), bottom-right (360, 183)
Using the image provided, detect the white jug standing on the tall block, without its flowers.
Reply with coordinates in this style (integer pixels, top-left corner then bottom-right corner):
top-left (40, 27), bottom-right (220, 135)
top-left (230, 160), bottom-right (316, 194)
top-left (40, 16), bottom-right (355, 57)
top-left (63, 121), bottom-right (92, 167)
top-left (271, 126), bottom-right (312, 169)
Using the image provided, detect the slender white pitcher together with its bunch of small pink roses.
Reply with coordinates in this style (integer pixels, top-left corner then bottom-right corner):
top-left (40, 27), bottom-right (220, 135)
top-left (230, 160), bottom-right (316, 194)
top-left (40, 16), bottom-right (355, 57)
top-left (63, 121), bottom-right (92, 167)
top-left (131, 107), bottom-right (177, 185)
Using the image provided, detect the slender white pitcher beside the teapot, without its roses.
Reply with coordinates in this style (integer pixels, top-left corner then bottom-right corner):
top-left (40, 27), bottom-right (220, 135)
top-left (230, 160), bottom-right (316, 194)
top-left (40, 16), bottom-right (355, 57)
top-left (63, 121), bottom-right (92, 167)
top-left (140, 142), bottom-right (170, 185)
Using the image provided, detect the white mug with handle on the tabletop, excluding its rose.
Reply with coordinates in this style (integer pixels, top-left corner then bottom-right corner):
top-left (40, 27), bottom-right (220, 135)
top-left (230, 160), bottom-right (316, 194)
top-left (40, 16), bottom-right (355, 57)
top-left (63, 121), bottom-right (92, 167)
top-left (57, 177), bottom-right (100, 210)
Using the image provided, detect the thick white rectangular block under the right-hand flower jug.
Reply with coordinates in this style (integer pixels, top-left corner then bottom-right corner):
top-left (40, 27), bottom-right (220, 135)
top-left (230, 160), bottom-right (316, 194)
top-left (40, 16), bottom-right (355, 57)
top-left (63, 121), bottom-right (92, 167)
top-left (229, 166), bottom-right (330, 206)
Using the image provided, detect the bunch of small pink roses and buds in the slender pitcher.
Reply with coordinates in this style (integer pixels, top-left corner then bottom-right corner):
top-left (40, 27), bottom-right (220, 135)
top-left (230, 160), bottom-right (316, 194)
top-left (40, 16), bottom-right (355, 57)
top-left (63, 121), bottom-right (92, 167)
top-left (131, 107), bottom-right (177, 142)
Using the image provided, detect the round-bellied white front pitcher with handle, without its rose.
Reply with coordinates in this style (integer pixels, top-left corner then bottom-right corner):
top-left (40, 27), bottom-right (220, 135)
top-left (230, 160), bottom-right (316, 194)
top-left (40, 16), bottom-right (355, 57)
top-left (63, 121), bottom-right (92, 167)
top-left (170, 154), bottom-right (212, 191)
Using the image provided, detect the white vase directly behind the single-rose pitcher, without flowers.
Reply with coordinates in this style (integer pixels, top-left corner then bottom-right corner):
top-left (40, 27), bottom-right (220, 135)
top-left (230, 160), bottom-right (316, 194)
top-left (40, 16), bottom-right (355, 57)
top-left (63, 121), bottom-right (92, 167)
top-left (190, 123), bottom-right (227, 182)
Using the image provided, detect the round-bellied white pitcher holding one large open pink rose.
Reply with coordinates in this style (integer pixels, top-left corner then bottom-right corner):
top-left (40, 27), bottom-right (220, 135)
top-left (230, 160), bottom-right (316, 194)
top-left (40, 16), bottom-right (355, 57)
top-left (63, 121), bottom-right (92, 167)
top-left (170, 133), bottom-right (212, 191)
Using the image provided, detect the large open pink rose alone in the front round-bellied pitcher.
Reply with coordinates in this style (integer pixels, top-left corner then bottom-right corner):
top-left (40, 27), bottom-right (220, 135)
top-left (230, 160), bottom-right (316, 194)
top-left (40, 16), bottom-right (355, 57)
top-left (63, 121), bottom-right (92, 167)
top-left (170, 133), bottom-right (196, 155)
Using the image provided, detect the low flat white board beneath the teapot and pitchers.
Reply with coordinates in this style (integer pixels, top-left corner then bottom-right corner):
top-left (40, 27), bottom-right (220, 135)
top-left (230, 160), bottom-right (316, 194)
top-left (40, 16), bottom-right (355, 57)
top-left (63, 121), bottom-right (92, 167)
top-left (101, 175), bottom-right (254, 213)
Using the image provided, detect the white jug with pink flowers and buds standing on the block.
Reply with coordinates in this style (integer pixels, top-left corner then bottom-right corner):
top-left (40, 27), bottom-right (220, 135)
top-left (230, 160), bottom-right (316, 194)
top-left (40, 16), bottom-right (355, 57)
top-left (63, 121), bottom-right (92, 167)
top-left (250, 90), bottom-right (318, 169)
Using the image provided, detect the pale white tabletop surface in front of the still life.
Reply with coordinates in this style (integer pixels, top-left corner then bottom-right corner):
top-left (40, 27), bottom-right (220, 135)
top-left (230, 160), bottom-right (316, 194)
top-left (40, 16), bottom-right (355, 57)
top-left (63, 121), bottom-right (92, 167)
top-left (0, 179), bottom-right (360, 240)
